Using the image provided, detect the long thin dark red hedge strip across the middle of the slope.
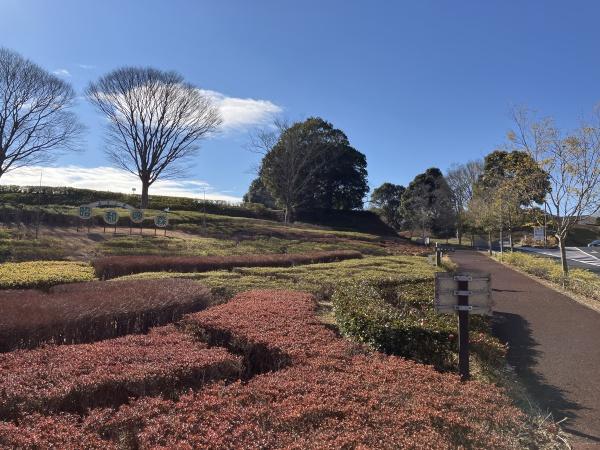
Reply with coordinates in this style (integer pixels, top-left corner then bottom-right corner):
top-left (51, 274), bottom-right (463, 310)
top-left (92, 250), bottom-right (362, 279)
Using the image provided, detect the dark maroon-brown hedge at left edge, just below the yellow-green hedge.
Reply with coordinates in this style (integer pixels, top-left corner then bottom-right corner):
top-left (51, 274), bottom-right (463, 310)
top-left (0, 279), bottom-right (211, 352)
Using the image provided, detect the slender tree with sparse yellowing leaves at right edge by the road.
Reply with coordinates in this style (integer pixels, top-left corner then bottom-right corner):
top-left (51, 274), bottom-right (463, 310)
top-left (508, 108), bottom-right (600, 276)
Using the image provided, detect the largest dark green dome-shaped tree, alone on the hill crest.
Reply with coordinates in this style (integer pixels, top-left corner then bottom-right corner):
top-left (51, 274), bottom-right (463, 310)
top-left (259, 117), bottom-right (368, 221)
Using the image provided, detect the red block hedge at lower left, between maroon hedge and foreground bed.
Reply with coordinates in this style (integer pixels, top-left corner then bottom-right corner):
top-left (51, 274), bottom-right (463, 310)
top-left (0, 325), bottom-right (242, 419)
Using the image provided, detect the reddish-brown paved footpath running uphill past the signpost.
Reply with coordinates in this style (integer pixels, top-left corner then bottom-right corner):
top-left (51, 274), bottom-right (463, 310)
top-left (451, 251), bottom-right (600, 448)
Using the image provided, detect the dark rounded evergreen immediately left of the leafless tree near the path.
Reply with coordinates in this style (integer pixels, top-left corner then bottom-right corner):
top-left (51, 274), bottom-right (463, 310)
top-left (401, 167), bottom-right (456, 237)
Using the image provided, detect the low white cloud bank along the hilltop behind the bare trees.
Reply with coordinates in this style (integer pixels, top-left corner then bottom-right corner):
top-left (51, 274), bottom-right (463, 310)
top-left (0, 166), bottom-right (241, 203)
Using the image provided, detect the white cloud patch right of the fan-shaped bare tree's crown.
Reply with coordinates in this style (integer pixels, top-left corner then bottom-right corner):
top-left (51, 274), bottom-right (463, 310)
top-left (200, 89), bottom-right (282, 131)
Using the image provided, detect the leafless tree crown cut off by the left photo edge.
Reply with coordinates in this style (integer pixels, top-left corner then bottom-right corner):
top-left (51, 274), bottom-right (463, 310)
top-left (0, 47), bottom-right (83, 176)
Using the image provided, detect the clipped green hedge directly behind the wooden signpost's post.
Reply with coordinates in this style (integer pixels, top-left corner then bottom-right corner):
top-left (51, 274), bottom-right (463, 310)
top-left (332, 279), bottom-right (505, 370)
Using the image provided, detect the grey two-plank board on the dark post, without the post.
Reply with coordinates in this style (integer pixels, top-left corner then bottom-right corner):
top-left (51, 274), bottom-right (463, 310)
top-left (434, 272), bottom-right (493, 315)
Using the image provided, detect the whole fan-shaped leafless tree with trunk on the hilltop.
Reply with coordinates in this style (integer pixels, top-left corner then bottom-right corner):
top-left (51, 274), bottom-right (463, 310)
top-left (86, 67), bottom-right (221, 208)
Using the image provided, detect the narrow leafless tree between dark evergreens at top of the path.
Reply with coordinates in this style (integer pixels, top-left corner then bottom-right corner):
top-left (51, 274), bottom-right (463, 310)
top-left (446, 160), bottom-right (483, 245)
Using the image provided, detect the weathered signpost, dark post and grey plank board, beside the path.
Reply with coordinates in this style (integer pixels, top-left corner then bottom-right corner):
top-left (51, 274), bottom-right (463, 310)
top-left (434, 272), bottom-right (493, 381)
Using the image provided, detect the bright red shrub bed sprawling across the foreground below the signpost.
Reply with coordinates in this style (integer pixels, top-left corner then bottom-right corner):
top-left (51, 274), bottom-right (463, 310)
top-left (0, 291), bottom-right (522, 449)
